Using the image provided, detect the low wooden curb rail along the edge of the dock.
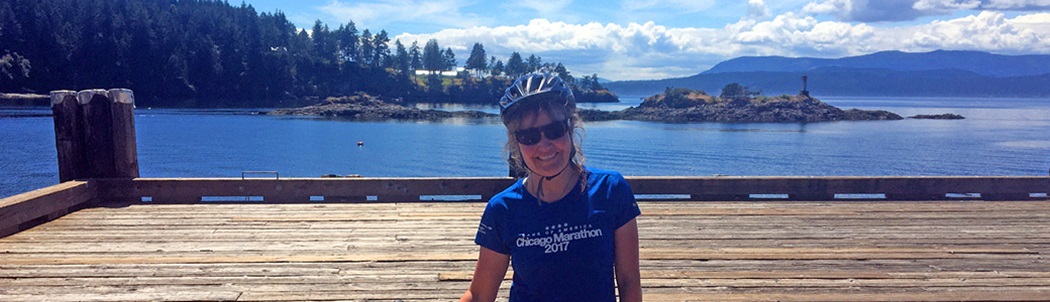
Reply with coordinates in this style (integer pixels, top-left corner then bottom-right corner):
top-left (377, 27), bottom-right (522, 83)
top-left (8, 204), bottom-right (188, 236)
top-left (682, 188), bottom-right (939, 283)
top-left (0, 176), bottom-right (1050, 236)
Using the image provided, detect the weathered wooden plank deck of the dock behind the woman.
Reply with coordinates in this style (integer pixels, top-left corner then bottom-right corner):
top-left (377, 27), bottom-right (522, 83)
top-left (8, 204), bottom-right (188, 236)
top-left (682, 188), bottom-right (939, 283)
top-left (0, 201), bottom-right (1050, 301)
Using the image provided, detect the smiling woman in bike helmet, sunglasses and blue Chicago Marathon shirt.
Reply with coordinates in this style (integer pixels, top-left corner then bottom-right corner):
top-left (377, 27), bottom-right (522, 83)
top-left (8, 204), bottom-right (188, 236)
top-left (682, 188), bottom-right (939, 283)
top-left (460, 72), bottom-right (642, 301)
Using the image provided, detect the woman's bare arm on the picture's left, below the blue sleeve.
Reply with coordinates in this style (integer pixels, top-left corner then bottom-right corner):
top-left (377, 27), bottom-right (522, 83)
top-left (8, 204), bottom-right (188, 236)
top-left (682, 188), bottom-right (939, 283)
top-left (460, 244), bottom-right (508, 302)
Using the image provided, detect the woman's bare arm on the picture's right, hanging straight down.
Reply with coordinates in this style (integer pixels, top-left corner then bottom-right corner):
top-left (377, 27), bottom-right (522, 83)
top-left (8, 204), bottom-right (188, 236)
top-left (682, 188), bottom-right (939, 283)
top-left (613, 219), bottom-right (642, 302)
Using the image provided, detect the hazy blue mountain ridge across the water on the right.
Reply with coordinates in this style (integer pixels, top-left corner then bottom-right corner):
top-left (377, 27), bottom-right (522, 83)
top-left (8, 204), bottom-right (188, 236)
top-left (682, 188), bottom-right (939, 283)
top-left (605, 50), bottom-right (1050, 98)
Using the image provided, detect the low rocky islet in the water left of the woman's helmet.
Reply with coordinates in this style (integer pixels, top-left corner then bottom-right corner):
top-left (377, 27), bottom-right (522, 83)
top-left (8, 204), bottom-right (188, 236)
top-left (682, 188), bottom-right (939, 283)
top-left (267, 93), bottom-right (497, 121)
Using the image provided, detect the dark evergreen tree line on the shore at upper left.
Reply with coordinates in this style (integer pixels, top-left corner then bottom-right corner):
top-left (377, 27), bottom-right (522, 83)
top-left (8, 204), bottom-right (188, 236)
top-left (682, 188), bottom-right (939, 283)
top-left (0, 0), bottom-right (615, 107)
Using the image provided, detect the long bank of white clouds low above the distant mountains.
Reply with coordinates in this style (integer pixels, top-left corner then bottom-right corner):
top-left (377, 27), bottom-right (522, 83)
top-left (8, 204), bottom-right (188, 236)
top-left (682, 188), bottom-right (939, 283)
top-left (395, 12), bottom-right (1050, 80)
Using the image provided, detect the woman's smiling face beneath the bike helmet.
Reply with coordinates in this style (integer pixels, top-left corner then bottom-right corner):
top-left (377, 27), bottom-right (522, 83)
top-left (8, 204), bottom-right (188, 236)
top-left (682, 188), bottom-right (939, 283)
top-left (517, 110), bottom-right (572, 176)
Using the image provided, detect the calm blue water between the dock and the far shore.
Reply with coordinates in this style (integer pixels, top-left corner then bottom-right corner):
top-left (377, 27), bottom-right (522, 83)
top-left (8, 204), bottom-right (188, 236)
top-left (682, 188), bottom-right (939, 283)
top-left (0, 96), bottom-right (1050, 197)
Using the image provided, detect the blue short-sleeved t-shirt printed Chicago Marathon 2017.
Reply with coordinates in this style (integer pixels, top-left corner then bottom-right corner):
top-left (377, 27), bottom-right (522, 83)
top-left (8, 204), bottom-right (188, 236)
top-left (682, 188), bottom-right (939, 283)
top-left (475, 168), bottom-right (642, 302)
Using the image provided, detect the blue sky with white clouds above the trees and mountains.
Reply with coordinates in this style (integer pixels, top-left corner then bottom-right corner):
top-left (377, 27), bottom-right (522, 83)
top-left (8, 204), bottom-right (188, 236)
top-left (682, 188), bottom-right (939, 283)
top-left (238, 0), bottom-right (1050, 80)
